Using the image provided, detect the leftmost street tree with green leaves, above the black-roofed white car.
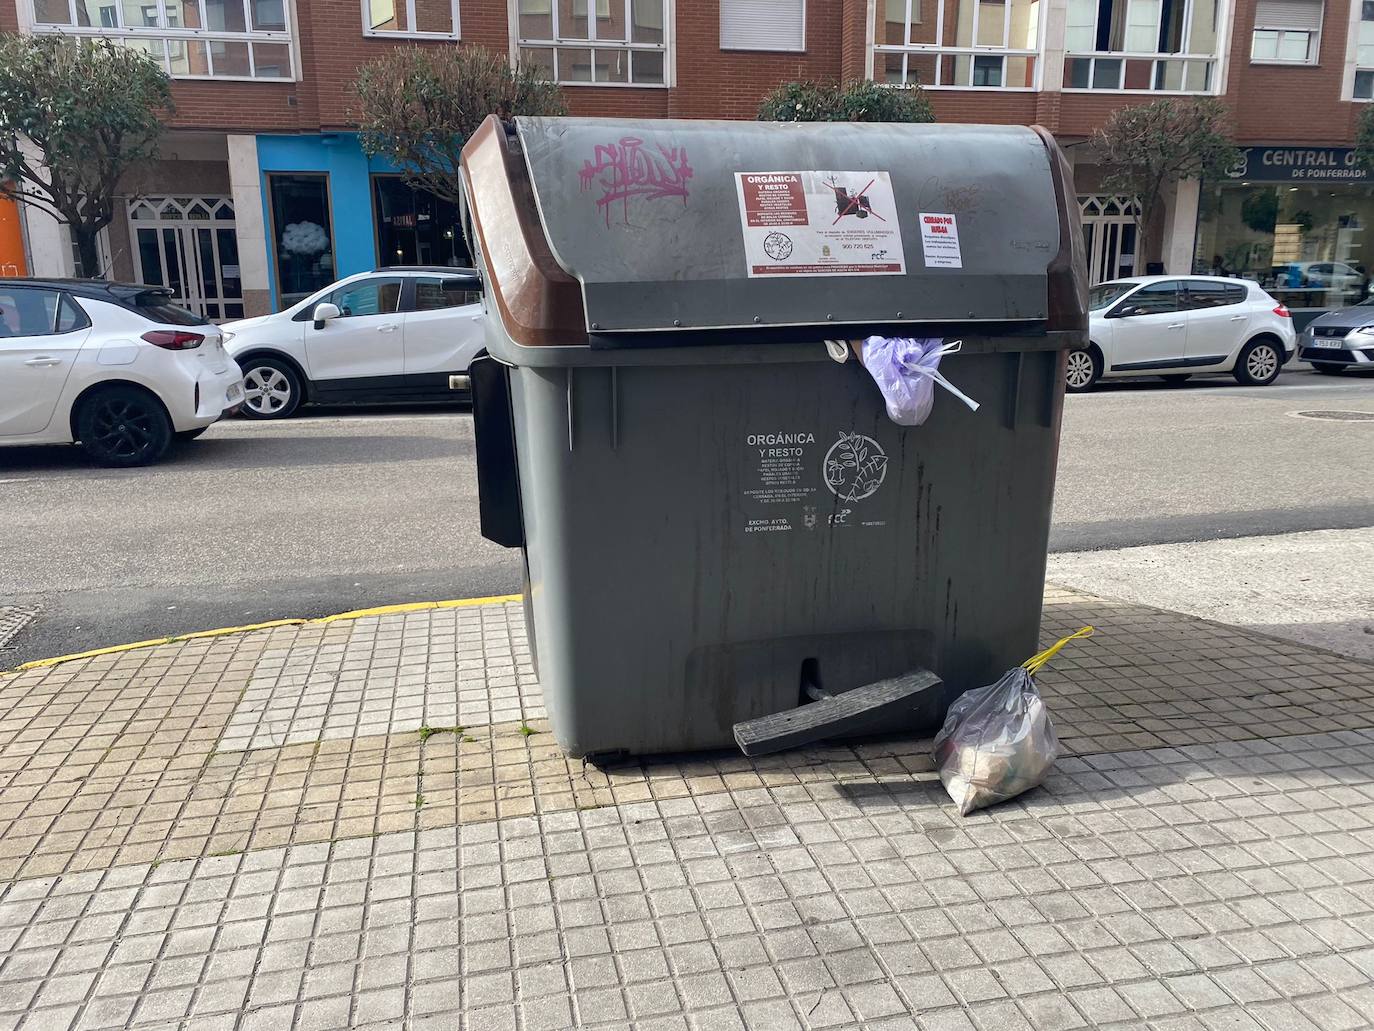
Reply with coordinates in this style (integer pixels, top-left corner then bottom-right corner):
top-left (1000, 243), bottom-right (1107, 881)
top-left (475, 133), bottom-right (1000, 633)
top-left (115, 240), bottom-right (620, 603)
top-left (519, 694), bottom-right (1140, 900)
top-left (0, 34), bottom-right (172, 276)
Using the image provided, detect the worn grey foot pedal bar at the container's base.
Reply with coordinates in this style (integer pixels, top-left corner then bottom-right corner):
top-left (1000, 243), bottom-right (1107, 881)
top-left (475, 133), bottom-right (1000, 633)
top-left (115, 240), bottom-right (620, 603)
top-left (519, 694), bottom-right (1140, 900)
top-left (735, 669), bottom-right (944, 755)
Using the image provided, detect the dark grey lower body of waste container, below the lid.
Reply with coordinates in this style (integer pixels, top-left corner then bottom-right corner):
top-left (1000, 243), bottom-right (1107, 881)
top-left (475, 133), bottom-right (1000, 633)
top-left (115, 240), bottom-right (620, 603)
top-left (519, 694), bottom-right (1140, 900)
top-left (510, 345), bottom-right (1061, 756)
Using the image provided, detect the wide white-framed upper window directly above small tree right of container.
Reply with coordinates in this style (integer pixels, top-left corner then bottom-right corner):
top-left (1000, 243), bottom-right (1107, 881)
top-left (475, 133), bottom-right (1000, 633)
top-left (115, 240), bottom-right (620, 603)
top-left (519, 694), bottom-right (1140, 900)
top-left (1063, 0), bottom-right (1220, 93)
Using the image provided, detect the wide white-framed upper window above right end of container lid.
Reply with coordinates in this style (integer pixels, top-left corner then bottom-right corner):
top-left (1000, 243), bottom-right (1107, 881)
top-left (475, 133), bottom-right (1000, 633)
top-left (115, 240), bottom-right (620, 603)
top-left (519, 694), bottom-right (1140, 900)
top-left (874, 0), bottom-right (1044, 89)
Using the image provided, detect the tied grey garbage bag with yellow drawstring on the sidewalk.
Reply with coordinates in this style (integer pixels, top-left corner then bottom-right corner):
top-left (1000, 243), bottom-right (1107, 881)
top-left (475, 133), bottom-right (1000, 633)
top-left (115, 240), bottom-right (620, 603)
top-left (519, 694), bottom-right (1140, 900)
top-left (934, 627), bottom-right (1092, 817)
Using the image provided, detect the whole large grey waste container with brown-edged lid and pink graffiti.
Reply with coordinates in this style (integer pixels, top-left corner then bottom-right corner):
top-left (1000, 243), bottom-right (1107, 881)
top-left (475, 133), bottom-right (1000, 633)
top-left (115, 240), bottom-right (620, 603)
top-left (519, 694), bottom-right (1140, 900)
top-left (463, 118), bottom-right (1087, 756)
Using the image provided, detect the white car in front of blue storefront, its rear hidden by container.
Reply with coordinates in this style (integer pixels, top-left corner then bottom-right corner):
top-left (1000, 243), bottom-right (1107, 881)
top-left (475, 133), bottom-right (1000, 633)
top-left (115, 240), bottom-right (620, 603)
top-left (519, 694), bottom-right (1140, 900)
top-left (224, 267), bottom-right (484, 419)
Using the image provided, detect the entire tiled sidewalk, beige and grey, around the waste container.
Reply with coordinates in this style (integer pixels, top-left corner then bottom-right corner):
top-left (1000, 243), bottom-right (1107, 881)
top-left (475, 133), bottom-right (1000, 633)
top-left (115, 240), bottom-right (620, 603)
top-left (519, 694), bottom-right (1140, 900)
top-left (0, 588), bottom-right (1374, 1031)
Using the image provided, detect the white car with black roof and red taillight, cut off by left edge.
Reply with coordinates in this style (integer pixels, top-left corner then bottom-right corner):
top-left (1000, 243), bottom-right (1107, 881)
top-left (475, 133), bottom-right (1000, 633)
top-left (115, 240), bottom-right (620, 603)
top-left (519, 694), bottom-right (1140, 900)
top-left (0, 279), bottom-right (243, 466)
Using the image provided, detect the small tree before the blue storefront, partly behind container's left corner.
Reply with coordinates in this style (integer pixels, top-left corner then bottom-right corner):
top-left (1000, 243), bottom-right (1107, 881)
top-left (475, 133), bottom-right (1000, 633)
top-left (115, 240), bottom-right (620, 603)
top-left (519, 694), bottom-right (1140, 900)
top-left (353, 47), bottom-right (567, 203)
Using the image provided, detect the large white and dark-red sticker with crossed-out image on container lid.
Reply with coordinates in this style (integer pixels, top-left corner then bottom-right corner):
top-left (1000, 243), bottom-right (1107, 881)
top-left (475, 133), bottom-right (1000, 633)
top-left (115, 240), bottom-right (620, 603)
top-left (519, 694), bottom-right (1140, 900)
top-left (735, 172), bottom-right (907, 278)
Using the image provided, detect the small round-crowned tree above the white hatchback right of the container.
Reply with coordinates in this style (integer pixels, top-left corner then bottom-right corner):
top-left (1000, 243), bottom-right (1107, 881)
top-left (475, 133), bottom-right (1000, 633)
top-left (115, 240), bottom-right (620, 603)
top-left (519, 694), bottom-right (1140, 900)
top-left (1092, 98), bottom-right (1241, 250)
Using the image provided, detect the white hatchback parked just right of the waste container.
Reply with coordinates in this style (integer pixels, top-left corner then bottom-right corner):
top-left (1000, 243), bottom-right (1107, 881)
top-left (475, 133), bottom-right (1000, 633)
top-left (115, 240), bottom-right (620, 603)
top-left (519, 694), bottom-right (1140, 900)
top-left (1065, 276), bottom-right (1297, 392)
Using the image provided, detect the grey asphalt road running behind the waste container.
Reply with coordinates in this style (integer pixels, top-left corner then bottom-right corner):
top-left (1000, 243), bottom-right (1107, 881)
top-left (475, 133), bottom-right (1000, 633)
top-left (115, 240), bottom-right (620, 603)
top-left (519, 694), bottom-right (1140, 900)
top-left (0, 371), bottom-right (1374, 668)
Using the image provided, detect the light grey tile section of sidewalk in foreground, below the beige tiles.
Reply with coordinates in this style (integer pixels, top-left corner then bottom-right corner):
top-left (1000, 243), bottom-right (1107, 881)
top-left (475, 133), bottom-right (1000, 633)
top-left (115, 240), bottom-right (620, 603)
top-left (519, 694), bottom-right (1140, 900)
top-left (0, 731), bottom-right (1374, 1031)
